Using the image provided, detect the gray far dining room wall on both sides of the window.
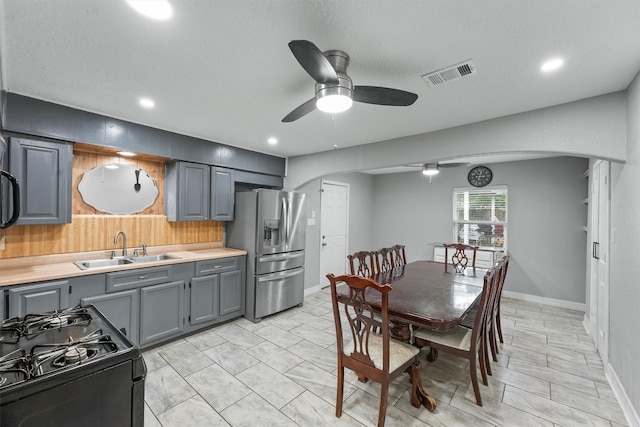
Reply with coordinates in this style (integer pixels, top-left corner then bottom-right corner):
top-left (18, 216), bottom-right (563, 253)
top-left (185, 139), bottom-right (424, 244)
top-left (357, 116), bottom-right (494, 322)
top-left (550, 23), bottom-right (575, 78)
top-left (371, 157), bottom-right (589, 304)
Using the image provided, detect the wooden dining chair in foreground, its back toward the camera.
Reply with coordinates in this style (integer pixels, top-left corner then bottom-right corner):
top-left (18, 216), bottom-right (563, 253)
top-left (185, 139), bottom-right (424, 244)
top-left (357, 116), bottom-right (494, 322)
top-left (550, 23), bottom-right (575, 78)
top-left (327, 274), bottom-right (424, 427)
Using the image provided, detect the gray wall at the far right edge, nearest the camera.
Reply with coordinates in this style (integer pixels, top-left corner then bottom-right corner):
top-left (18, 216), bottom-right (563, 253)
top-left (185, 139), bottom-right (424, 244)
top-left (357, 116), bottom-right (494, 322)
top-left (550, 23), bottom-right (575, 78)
top-left (609, 74), bottom-right (640, 414)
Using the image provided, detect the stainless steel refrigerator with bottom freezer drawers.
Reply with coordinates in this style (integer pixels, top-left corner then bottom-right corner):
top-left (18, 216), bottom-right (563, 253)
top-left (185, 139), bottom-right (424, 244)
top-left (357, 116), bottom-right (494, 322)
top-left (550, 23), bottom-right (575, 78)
top-left (226, 189), bottom-right (307, 322)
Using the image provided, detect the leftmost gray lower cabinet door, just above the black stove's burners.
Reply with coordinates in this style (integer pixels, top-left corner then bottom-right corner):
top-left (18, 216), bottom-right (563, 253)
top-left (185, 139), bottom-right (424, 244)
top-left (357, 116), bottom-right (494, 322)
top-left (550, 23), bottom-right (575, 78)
top-left (8, 280), bottom-right (69, 317)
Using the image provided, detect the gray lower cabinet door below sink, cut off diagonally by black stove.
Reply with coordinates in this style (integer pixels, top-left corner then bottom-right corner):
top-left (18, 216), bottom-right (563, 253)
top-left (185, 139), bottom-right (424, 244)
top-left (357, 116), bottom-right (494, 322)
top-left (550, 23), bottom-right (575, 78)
top-left (80, 289), bottom-right (140, 344)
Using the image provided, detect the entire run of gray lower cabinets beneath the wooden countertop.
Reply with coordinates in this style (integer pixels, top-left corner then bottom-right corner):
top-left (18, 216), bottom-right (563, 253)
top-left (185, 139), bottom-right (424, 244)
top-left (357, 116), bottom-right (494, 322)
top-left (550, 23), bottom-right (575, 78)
top-left (5, 256), bottom-right (246, 347)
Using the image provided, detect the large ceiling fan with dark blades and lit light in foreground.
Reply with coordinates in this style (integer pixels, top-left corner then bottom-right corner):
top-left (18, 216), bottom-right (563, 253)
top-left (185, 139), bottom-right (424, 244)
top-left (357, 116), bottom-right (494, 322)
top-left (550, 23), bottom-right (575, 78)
top-left (282, 40), bottom-right (418, 123)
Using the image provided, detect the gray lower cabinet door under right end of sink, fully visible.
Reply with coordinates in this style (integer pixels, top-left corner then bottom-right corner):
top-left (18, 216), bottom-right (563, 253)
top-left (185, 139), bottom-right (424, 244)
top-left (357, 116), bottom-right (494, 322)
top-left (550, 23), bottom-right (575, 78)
top-left (140, 281), bottom-right (184, 345)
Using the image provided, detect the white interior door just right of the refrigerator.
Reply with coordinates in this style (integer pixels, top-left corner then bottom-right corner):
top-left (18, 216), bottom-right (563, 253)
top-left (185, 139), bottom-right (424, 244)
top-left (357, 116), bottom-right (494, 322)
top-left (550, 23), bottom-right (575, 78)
top-left (319, 180), bottom-right (349, 287)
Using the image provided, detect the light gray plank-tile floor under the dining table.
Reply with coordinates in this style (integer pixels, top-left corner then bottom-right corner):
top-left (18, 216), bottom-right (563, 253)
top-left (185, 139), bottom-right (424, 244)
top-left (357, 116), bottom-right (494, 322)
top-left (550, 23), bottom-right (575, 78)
top-left (144, 289), bottom-right (627, 427)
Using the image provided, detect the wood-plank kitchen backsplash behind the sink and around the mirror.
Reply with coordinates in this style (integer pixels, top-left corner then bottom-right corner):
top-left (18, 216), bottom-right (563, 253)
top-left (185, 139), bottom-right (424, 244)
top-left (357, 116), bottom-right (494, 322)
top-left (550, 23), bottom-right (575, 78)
top-left (0, 151), bottom-right (223, 259)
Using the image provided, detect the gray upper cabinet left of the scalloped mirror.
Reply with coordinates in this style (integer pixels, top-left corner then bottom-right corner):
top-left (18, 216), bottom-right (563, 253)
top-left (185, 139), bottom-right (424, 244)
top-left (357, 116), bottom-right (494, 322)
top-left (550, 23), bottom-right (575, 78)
top-left (9, 138), bottom-right (73, 225)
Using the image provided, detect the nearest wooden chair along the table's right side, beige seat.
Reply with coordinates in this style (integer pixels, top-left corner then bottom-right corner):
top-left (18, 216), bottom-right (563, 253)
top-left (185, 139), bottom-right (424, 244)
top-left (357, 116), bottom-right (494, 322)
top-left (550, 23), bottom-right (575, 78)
top-left (413, 267), bottom-right (497, 406)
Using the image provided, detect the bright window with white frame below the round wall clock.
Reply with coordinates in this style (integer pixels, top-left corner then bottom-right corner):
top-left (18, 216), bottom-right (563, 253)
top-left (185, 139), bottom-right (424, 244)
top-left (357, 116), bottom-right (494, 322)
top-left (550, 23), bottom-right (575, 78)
top-left (453, 186), bottom-right (508, 254)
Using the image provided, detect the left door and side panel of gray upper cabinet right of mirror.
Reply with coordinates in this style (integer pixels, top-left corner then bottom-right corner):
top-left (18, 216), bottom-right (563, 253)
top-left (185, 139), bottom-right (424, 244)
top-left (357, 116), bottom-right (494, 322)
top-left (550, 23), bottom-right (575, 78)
top-left (164, 162), bottom-right (211, 221)
